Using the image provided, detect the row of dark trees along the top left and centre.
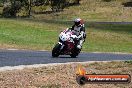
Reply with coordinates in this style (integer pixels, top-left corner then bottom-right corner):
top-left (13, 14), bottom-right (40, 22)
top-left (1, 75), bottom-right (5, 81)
top-left (1, 0), bottom-right (80, 17)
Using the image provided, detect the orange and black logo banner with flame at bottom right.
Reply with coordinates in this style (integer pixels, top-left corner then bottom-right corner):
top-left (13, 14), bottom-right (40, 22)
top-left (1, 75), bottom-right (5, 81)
top-left (76, 66), bottom-right (131, 85)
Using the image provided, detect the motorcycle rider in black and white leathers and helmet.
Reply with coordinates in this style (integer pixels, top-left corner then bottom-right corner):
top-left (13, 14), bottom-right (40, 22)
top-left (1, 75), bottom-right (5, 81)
top-left (69, 18), bottom-right (86, 50)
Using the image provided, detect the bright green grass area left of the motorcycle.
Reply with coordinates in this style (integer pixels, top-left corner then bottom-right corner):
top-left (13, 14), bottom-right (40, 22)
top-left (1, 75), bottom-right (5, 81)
top-left (0, 19), bottom-right (58, 49)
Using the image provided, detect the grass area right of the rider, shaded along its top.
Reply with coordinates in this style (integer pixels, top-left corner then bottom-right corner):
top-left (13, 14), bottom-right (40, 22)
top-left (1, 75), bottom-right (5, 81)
top-left (84, 24), bottom-right (132, 52)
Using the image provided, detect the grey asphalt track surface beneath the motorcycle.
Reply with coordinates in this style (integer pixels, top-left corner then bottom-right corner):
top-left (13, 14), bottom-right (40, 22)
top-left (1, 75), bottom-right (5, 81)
top-left (0, 50), bottom-right (132, 67)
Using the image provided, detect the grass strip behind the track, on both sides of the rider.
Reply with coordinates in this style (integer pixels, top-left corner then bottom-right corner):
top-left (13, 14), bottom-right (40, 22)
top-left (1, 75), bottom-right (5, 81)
top-left (0, 19), bottom-right (132, 53)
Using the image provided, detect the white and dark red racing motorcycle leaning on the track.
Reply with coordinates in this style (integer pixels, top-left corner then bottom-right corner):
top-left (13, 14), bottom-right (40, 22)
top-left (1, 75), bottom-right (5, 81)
top-left (52, 29), bottom-right (80, 58)
